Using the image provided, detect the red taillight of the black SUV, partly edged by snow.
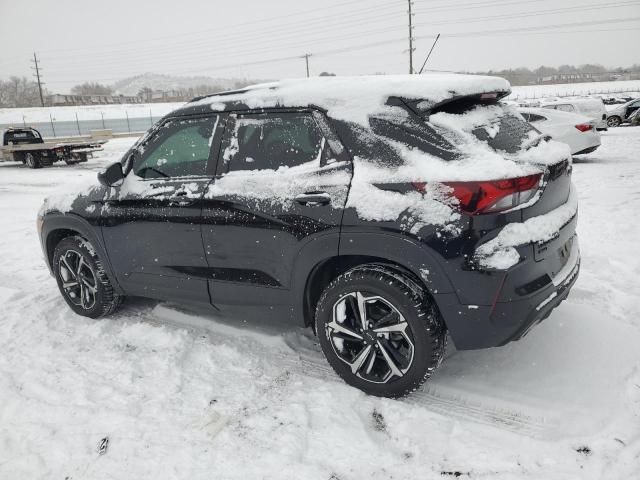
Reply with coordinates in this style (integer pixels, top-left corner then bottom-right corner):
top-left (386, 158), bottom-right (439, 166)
top-left (413, 173), bottom-right (542, 215)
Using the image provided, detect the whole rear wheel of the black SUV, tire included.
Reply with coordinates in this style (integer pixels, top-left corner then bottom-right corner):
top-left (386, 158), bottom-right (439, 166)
top-left (315, 264), bottom-right (446, 398)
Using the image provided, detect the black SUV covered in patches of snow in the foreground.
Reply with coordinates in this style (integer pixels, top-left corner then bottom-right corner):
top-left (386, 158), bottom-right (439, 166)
top-left (38, 75), bottom-right (579, 397)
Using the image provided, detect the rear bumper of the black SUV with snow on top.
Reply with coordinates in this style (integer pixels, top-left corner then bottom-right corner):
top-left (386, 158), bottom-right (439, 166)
top-left (434, 172), bottom-right (580, 350)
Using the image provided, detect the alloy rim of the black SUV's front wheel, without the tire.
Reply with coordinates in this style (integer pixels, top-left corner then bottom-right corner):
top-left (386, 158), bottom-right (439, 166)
top-left (58, 250), bottom-right (98, 310)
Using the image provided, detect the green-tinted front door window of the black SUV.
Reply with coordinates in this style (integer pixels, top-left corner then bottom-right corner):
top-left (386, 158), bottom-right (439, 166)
top-left (133, 117), bottom-right (215, 178)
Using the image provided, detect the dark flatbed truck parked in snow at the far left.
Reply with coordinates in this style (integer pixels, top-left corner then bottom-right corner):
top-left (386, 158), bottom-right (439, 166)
top-left (0, 127), bottom-right (106, 168)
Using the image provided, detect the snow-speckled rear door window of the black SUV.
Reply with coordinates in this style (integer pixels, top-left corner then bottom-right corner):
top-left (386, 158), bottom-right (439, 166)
top-left (222, 113), bottom-right (325, 173)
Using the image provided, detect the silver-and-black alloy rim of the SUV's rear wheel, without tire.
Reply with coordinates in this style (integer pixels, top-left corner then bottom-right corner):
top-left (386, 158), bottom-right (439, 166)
top-left (326, 291), bottom-right (415, 383)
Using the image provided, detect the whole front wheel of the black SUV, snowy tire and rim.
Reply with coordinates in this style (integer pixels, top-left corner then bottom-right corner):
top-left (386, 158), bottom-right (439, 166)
top-left (53, 236), bottom-right (122, 318)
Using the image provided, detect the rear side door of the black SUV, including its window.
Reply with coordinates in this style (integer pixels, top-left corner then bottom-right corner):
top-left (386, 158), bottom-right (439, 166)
top-left (202, 111), bottom-right (352, 321)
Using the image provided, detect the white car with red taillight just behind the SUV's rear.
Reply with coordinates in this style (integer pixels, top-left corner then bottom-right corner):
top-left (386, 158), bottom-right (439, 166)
top-left (518, 108), bottom-right (600, 155)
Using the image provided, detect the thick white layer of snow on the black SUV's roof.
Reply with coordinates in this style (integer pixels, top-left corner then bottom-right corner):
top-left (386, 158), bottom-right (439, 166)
top-left (191, 73), bottom-right (511, 125)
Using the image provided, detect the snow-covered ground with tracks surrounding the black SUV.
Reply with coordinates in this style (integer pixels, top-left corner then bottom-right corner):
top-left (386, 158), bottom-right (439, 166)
top-left (0, 131), bottom-right (640, 480)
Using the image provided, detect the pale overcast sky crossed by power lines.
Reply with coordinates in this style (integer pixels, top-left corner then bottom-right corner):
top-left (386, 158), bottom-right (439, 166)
top-left (0, 0), bottom-right (640, 92)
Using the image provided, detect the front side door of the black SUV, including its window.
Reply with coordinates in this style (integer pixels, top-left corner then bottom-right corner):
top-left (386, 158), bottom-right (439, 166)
top-left (101, 115), bottom-right (220, 303)
